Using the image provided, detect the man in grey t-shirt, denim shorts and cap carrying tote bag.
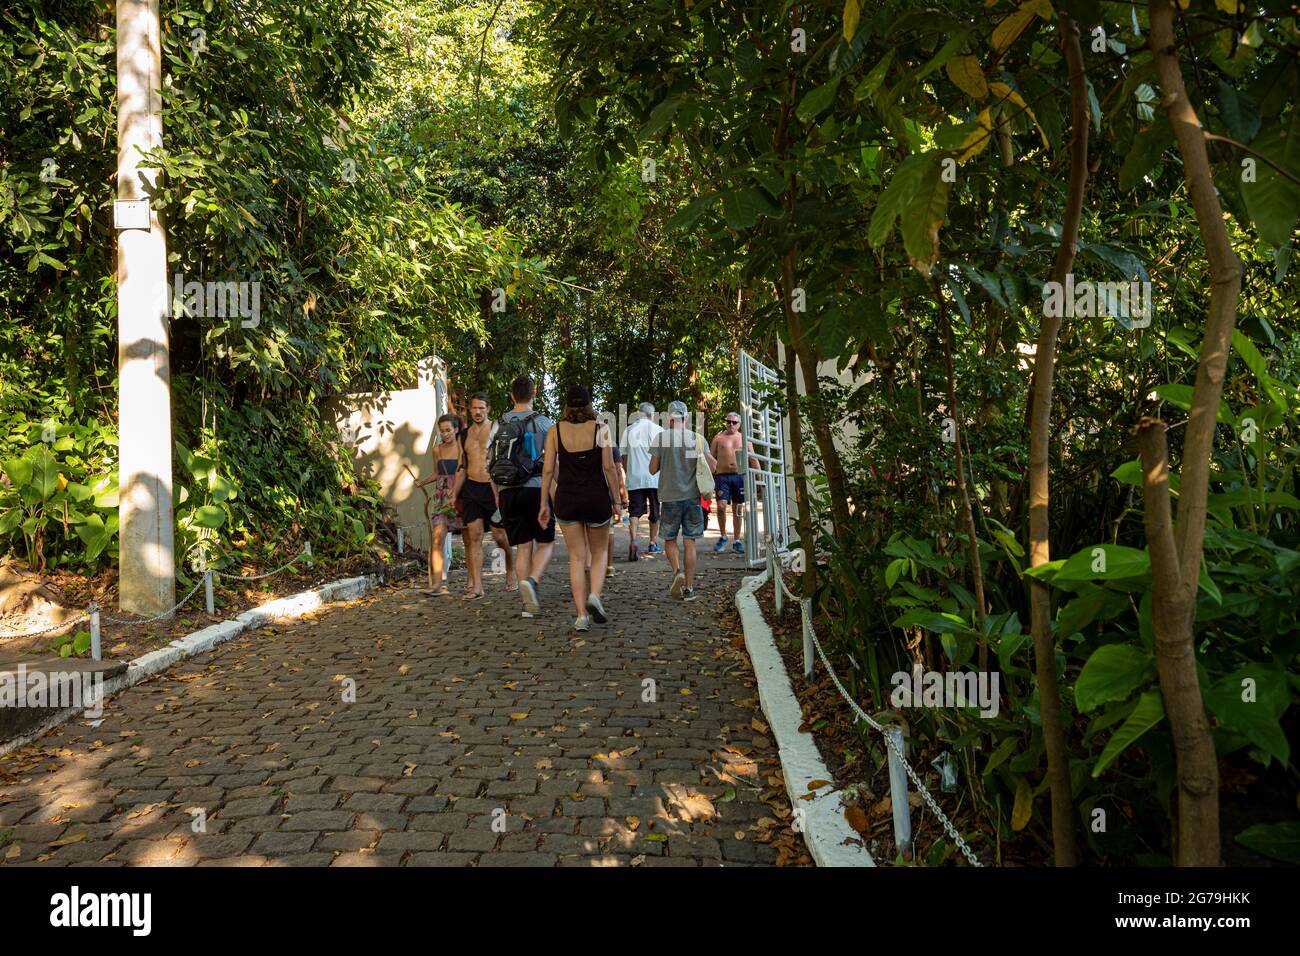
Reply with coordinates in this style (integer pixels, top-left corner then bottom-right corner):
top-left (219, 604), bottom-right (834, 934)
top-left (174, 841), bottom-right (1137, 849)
top-left (649, 402), bottom-right (718, 601)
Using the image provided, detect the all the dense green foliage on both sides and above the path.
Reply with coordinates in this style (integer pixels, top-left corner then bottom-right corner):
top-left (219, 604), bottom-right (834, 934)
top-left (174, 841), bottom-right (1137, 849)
top-left (0, 0), bottom-right (1300, 862)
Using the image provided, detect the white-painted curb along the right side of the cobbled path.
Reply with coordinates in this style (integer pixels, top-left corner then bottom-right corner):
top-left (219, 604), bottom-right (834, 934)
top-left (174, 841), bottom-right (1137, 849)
top-left (736, 571), bottom-right (876, 866)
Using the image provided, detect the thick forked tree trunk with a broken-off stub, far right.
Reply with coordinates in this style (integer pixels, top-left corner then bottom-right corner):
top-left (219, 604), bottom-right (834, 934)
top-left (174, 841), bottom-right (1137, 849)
top-left (1138, 0), bottom-right (1242, 866)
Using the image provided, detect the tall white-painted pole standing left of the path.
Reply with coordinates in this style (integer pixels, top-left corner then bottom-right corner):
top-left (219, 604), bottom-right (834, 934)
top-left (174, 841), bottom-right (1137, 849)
top-left (117, 0), bottom-right (176, 614)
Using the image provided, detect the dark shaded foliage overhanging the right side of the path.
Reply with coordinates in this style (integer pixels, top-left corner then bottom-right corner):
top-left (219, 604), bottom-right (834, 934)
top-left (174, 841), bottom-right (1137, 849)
top-left (538, 0), bottom-right (1300, 862)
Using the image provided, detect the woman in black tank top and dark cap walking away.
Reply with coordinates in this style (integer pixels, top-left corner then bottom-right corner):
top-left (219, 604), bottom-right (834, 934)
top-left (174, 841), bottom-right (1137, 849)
top-left (537, 385), bottom-right (620, 631)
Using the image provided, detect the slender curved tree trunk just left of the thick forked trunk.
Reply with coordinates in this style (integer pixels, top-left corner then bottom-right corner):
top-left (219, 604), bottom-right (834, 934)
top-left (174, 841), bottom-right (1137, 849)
top-left (1030, 12), bottom-right (1088, 866)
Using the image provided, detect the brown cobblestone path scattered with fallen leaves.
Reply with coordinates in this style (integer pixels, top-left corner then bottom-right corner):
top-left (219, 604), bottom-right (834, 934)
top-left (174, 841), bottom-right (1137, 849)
top-left (0, 533), bottom-right (779, 866)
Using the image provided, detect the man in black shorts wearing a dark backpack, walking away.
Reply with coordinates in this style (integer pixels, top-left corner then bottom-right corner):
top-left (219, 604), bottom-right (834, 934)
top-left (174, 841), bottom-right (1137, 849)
top-left (489, 375), bottom-right (555, 618)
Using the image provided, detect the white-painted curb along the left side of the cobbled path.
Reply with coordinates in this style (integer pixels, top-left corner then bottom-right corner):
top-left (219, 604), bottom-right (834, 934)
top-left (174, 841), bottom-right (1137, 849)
top-left (0, 575), bottom-right (376, 757)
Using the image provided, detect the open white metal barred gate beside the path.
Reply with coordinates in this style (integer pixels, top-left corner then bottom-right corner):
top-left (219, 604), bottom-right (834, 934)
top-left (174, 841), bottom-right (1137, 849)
top-left (740, 351), bottom-right (789, 567)
